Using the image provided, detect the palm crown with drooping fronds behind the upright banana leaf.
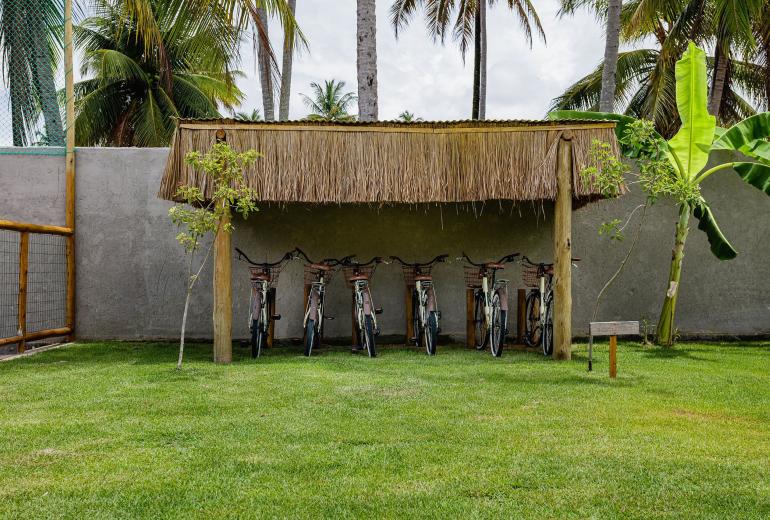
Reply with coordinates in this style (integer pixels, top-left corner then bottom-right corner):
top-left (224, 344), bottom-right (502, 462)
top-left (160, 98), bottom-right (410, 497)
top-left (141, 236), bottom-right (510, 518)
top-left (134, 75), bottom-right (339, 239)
top-left (551, 0), bottom-right (764, 138)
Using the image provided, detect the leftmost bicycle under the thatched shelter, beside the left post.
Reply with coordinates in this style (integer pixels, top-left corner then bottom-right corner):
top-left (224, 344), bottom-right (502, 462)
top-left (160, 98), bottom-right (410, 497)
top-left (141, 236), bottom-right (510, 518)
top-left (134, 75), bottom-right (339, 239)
top-left (235, 247), bottom-right (296, 358)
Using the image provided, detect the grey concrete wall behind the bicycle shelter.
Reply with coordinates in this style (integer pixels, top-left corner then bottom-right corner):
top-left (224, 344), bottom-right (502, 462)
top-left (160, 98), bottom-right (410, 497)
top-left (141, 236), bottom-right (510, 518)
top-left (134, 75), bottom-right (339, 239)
top-left (0, 148), bottom-right (770, 338)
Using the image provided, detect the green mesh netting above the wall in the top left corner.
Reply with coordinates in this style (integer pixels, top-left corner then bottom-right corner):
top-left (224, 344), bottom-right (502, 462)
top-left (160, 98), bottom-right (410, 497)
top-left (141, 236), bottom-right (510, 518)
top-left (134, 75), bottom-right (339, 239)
top-left (0, 0), bottom-right (65, 155)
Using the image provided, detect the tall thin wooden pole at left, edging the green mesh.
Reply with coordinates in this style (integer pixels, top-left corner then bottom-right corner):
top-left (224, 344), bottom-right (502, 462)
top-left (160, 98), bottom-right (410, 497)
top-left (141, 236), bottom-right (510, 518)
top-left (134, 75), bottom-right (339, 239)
top-left (64, 0), bottom-right (75, 341)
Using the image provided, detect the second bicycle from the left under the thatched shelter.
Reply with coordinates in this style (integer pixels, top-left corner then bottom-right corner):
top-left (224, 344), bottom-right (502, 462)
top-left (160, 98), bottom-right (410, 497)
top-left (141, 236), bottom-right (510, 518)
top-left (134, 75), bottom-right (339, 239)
top-left (296, 248), bottom-right (353, 357)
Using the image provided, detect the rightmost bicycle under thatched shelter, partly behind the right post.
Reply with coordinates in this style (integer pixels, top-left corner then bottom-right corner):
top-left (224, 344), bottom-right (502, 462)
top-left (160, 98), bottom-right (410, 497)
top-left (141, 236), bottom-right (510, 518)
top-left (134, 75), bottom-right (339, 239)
top-left (521, 256), bottom-right (580, 356)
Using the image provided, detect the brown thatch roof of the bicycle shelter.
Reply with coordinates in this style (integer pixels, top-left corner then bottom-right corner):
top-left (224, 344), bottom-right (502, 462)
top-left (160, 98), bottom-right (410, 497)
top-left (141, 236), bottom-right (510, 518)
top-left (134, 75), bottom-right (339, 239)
top-left (159, 119), bottom-right (617, 203)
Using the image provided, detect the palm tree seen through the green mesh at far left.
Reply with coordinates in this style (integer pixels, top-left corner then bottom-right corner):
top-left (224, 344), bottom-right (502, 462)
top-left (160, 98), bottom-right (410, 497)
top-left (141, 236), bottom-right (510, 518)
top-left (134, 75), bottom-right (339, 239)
top-left (0, 0), bottom-right (64, 146)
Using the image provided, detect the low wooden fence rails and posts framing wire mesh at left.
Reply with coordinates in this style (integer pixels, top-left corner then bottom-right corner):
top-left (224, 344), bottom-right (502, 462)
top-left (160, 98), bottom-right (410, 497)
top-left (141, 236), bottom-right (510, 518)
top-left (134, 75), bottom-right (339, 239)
top-left (0, 220), bottom-right (74, 353)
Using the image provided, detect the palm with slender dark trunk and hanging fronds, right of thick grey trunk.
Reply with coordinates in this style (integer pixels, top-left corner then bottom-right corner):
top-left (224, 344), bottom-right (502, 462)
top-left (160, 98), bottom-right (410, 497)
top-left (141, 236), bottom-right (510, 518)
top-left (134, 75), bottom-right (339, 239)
top-left (390, 0), bottom-right (545, 119)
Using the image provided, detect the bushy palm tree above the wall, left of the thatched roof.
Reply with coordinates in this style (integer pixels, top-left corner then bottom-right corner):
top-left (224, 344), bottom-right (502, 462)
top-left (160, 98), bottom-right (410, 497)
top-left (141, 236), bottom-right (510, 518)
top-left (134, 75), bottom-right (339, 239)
top-left (75, 0), bottom-right (242, 146)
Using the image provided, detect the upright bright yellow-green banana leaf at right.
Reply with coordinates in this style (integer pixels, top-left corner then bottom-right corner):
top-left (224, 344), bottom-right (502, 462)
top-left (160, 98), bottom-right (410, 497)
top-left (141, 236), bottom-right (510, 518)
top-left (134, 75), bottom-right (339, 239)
top-left (669, 42), bottom-right (716, 179)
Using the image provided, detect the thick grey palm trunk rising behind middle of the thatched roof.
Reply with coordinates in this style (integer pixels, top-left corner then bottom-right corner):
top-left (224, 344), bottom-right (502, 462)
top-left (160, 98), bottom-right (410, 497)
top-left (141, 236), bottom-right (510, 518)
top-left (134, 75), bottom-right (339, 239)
top-left (356, 0), bottom-right (378, 121)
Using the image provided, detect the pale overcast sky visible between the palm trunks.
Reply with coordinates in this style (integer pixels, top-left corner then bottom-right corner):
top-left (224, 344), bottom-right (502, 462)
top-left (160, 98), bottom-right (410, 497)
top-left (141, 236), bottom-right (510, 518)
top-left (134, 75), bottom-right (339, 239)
top-left (240, 0), bottom-right (604, 120)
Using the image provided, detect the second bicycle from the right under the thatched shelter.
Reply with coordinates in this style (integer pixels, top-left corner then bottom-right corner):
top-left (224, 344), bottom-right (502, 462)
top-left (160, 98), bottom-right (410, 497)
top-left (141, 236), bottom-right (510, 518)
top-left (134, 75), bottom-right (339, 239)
top-left (458, 253), bottom-right (519, 357)
